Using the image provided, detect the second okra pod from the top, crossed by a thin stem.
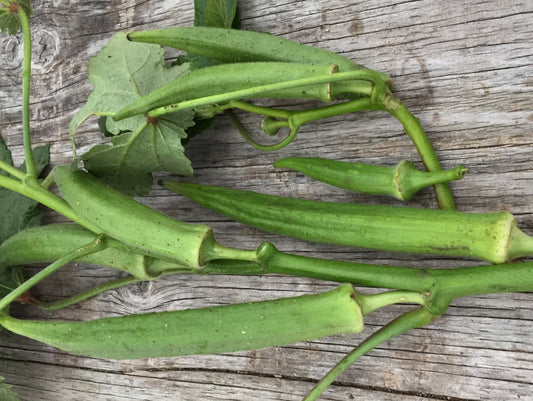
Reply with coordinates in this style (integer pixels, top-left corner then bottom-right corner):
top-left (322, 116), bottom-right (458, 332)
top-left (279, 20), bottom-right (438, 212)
top-left (113, 62), bottom-right (338, 121)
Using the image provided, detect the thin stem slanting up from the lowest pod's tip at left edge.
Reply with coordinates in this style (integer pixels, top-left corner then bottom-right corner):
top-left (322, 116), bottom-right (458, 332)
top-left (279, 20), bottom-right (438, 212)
top-left (0, 237), bottom-right (106, 311)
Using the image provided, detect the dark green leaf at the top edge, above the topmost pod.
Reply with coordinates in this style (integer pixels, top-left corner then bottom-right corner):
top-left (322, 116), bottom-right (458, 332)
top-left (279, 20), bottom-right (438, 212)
top-left (194, 0), bottom-right (237, 28)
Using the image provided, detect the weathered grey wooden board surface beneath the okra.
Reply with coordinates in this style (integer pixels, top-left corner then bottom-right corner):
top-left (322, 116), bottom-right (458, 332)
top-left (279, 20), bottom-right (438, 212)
top-left (0, 0), bottom-right (533, 401)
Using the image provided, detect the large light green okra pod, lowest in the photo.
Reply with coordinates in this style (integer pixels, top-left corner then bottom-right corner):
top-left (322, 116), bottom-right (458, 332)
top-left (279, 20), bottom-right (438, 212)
top-left (0, 284), bottom-right (363, 359)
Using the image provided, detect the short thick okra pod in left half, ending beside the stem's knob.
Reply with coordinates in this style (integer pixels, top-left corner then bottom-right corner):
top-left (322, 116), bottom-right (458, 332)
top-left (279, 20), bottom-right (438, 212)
top-left (53, 165), bottom-right (218, 268)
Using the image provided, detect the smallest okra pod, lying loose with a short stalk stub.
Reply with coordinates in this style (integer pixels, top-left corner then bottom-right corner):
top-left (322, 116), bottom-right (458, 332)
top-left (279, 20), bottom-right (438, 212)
top-left (274, 157), bottom-right (466, 201)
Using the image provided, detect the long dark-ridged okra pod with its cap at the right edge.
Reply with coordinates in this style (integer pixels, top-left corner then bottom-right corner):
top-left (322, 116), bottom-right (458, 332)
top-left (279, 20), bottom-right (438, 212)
top-left (164, 181), bottom-right (533, 263)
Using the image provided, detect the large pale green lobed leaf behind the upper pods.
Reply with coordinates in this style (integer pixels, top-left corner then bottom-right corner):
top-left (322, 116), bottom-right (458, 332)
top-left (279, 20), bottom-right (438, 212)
top-left (69, 33), bottom-right (194, 196)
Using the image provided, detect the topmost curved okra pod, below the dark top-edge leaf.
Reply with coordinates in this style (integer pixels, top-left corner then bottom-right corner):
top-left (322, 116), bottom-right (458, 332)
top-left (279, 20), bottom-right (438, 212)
top-left (124, 27), bottom-right (392, 85)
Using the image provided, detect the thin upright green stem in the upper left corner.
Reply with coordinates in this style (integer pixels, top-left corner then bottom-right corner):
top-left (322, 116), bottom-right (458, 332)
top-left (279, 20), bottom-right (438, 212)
top-left (17, 6), bottom-right (37, 178)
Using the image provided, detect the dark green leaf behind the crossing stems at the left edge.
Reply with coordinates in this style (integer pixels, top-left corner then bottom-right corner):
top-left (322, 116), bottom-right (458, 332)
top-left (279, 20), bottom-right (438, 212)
top-left (0, 144), bottom-right (50, 244)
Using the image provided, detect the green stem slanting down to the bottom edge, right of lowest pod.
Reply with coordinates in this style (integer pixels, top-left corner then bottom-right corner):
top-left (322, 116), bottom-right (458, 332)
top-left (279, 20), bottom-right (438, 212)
top-left (304, 308), bottom-right (437, 401)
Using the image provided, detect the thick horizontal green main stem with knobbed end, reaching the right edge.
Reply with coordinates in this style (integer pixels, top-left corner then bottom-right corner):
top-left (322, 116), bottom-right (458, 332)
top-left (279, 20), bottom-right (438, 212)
top-left (252, 242), bottom-right (533, 300)
